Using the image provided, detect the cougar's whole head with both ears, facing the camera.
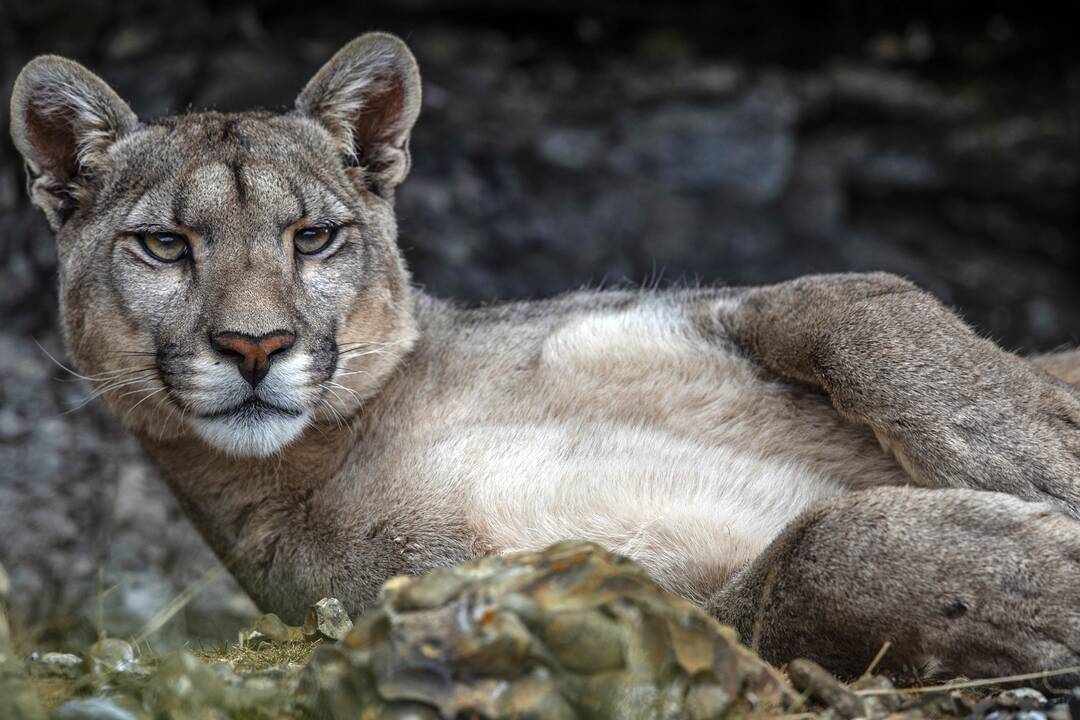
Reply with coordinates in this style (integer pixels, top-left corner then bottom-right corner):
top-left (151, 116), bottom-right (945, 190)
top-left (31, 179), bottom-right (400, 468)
top-left (12, 35), bottom-right (419, 456)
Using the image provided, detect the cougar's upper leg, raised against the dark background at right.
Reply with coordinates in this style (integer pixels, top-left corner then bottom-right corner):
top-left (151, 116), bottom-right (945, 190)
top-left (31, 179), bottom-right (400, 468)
top-left (718, 274), bottom-right (1080, 515)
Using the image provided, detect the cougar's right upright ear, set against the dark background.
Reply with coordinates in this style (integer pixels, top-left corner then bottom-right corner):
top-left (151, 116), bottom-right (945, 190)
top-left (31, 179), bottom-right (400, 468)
top-left (296, 32), bottom-right (420, 198)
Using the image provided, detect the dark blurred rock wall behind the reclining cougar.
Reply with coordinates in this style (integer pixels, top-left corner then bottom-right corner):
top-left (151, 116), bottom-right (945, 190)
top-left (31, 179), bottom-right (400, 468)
top-left (0, 0), bottom-right (1080, 643)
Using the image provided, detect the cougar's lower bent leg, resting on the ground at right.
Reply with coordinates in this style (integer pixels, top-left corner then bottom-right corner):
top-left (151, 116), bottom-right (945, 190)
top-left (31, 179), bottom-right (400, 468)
top-left (710, 487), bottom-right (1080, 678)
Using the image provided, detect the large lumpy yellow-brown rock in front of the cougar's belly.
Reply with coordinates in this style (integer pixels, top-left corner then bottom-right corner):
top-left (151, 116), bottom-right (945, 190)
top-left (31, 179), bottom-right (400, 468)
top-left (301, 543), bottom-right (789, 720)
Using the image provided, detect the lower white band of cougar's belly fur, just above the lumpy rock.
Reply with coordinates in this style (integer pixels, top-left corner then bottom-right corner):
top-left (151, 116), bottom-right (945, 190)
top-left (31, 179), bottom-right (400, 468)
top-left (446, 422), bottom-right (845, 599)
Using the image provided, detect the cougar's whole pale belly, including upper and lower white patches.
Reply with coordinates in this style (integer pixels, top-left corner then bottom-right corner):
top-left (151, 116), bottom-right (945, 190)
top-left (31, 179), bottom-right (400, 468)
top-left (455, 298), bottom-right (906, 600)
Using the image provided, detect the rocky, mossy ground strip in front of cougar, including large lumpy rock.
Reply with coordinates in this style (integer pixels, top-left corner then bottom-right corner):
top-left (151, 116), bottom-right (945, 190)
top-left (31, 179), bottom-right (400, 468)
top-left (0, 544), bottom-right (1080, 720)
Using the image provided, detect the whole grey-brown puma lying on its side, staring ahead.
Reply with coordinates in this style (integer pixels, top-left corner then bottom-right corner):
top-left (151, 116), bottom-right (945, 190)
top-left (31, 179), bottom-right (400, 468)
top-left (12, 33), bottom-right (1080, 677)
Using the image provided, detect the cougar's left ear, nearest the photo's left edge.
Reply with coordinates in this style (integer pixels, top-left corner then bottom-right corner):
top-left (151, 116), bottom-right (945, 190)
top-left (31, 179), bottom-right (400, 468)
top-left (11, 55), bottom-right (138, 229)
